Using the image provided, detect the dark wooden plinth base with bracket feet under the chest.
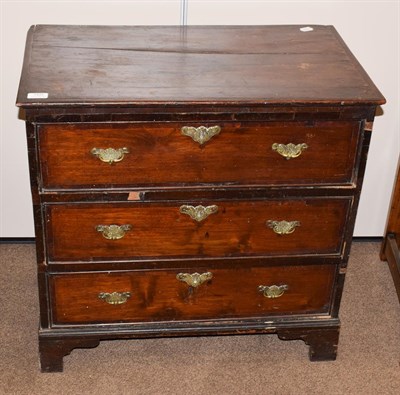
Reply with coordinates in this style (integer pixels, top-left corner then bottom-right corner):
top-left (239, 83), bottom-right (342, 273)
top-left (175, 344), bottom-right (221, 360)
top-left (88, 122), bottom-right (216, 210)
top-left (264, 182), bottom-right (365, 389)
top-left (39, 318), bottom-right (339, 372)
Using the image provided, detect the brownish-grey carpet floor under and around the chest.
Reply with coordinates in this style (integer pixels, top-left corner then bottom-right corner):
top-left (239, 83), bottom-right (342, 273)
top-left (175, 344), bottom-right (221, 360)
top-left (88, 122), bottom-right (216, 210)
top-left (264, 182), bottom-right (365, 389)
top-left (0, 242), bottom-right (400, 395)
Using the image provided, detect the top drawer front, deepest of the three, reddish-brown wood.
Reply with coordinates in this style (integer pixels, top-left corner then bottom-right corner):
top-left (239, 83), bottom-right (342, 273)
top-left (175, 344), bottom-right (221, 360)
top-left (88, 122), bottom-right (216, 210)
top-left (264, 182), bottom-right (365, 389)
top-left (39, 122), bottom-right (359, 189)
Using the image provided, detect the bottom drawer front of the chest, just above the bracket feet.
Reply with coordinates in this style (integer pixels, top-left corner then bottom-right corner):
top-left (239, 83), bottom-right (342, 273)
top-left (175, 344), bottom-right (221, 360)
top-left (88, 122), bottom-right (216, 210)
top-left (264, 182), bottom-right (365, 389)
top-left (49, 265), bottom-right (336, 325)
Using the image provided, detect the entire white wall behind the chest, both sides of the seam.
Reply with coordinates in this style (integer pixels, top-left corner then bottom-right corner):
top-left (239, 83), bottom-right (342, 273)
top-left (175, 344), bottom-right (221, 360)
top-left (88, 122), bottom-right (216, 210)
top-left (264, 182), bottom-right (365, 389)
top-left (0, 0), bottom-right (400, 237)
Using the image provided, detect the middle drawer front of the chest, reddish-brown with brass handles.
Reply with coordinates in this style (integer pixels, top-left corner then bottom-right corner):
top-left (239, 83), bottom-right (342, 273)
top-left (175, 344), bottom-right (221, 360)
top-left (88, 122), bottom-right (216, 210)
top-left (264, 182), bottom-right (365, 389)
top-left (46, 198), bottom-right (351, 261)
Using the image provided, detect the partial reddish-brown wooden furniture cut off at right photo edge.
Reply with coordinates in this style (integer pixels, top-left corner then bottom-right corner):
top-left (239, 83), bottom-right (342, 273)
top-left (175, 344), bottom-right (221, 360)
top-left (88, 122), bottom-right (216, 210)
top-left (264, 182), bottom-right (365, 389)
top-left (381, 164), bottom-right (400, 301)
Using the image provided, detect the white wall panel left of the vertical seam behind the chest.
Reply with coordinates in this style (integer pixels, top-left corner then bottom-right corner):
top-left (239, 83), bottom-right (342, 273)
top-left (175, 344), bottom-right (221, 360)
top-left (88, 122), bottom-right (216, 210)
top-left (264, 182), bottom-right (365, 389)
top-left (0, 0), bottom-right (181, 237)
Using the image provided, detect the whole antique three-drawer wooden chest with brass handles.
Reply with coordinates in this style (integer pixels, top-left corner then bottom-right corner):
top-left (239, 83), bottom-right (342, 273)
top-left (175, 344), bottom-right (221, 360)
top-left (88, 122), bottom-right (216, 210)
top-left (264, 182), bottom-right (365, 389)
top-left (17, 25), bottom-right (384, 372)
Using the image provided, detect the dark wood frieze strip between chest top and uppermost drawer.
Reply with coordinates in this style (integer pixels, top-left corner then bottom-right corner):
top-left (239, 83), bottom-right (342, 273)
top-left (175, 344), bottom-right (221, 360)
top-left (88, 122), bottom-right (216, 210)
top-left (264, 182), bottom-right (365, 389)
top-left (21, 102), bottom-right (376, 123)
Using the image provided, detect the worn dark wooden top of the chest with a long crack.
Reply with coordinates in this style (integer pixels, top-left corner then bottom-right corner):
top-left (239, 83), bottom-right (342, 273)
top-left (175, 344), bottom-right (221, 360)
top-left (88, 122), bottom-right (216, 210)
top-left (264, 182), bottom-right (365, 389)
top-left (17, 25), bottom-right (384, 107)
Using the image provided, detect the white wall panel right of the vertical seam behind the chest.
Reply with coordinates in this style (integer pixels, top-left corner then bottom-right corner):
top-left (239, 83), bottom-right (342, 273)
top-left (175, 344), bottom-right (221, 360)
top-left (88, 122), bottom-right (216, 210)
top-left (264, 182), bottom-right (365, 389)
top-left (188, 0), bottom-right (400, 236)
